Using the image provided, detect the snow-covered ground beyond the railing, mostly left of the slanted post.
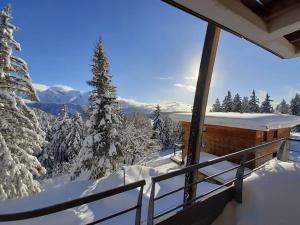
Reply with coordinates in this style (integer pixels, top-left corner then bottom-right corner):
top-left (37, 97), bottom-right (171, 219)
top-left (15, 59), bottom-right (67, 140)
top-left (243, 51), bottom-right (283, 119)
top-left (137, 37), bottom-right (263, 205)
top-left (0, 151), bottom-right (218, 225)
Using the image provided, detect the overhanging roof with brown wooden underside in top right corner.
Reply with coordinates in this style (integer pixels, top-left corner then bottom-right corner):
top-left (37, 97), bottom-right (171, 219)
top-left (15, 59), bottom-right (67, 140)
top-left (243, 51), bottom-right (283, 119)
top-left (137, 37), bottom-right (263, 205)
top-left (163, 0), bottom-right (300, 58)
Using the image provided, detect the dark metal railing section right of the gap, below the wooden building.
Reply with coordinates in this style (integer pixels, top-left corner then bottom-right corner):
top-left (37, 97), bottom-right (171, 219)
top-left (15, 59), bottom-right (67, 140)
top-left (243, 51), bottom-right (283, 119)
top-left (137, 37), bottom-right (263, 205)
top-left (147, 138), bottom-right (286, 225)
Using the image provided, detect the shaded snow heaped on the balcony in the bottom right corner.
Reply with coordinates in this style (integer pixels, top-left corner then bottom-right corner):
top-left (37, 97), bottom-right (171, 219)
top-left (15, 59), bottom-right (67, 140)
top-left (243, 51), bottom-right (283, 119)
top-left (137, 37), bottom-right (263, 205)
top-left (213, 160), bottom-right (300, 225)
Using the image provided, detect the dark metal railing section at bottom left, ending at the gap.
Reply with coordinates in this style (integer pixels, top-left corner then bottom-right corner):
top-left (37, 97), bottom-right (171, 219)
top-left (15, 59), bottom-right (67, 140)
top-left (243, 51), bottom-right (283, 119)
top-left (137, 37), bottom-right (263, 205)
top-left (0, 180), bottom-right (145, 225)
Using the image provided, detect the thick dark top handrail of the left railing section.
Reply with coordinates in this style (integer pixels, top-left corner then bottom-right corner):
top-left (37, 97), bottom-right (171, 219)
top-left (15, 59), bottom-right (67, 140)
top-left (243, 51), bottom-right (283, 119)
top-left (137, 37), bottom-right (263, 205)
top-left (0, 180), bottom-right (146, 221)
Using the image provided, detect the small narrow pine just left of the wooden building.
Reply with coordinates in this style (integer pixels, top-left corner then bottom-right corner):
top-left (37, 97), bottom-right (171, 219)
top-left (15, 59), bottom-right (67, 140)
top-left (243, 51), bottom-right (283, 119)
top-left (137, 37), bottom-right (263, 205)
top-left (152, 105), bottom-right (166, 145)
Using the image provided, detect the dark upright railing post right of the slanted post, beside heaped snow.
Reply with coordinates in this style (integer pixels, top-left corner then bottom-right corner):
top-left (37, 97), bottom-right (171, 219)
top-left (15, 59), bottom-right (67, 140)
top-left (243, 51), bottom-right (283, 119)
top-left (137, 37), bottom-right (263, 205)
top-left (234, 155), bottom-right (247, 203)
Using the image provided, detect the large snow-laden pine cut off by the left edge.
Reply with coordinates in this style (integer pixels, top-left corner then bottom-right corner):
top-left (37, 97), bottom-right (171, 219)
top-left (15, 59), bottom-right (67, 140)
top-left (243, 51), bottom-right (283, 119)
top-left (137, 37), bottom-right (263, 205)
top-left (0, 5), bottom-right (45, 199)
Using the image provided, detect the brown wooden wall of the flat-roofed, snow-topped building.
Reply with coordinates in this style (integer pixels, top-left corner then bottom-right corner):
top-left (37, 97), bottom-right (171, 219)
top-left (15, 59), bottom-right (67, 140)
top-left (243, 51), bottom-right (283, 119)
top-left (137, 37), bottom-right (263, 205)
top-left (181, 122), bottom-right (291, 168)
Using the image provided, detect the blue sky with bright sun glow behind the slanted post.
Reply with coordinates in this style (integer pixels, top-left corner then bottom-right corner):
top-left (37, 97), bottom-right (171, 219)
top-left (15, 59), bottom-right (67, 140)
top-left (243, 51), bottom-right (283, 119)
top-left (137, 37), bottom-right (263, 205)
top-left (0, 0), bottom-right (300, 105)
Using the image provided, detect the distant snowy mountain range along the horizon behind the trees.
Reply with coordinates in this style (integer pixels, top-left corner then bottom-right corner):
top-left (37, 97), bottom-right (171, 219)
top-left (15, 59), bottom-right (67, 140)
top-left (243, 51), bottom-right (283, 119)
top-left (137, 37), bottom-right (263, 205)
top-left (28, 84), bottom-right (191, 115)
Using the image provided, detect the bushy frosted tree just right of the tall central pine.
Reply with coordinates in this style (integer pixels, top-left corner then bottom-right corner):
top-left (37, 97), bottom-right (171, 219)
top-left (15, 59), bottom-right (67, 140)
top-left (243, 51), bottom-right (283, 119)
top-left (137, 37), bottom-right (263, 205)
top-left (120, 112), bottom-right (158, 165)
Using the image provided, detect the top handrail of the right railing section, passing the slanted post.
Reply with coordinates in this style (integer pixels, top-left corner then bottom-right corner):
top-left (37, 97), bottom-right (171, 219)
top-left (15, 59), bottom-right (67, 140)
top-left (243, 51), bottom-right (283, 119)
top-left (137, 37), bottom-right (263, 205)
top-left (152, 138), bottom-right (285, 183)
